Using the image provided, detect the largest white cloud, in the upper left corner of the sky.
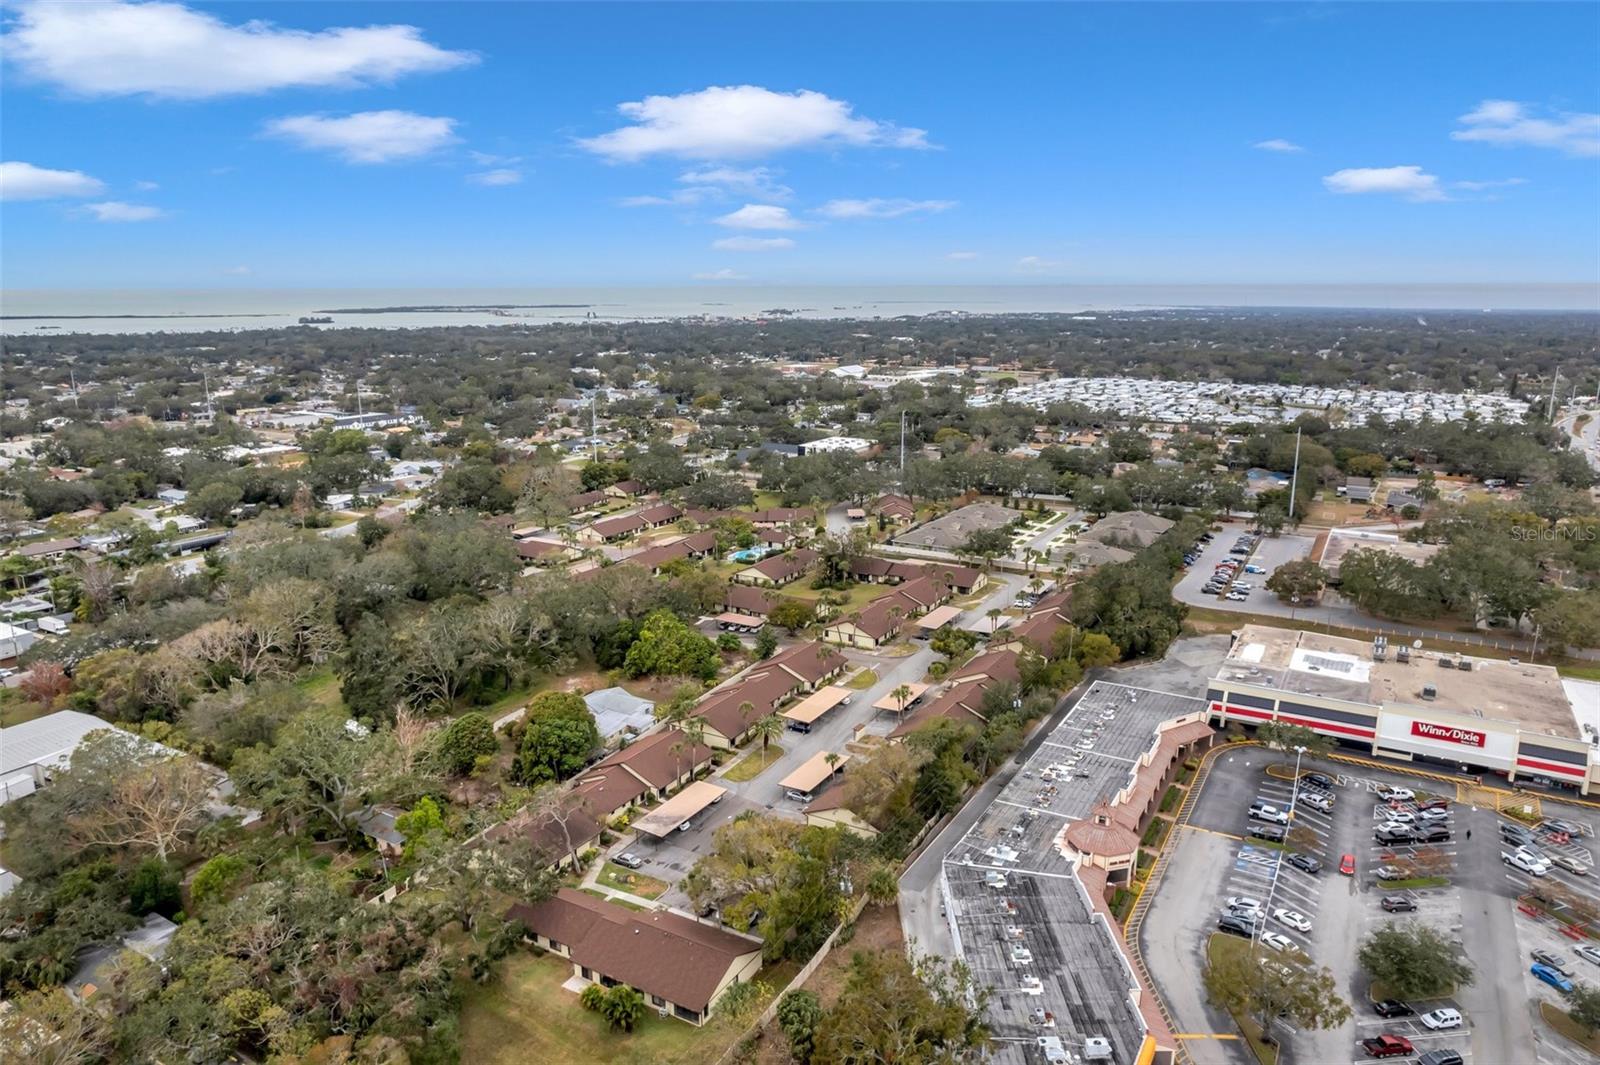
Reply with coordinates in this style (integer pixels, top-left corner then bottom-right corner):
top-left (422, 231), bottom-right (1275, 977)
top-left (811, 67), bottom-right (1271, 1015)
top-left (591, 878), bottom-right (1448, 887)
top-left (5, 2), bottom-right (477, 99)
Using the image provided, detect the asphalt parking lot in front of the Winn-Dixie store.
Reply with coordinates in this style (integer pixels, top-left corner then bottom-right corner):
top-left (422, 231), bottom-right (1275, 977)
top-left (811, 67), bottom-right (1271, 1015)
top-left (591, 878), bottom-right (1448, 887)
top-left (1141, 747), bottom-right (1600, 1065)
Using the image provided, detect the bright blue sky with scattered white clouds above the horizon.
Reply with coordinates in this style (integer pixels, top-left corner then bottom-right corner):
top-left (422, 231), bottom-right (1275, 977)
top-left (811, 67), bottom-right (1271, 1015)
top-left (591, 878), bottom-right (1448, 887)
top-left (0, 0), bottom-right (1600, 288)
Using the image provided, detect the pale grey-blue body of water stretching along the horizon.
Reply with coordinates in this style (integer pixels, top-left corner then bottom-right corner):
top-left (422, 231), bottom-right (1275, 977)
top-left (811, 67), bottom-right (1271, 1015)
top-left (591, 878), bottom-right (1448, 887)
top-left (0, 285), bottom-right (1600, 336)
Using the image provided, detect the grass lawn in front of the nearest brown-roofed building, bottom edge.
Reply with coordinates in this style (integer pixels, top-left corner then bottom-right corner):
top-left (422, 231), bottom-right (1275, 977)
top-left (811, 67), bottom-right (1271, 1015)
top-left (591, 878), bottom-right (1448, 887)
top-left (461, 953), bottom-right (766, 1065)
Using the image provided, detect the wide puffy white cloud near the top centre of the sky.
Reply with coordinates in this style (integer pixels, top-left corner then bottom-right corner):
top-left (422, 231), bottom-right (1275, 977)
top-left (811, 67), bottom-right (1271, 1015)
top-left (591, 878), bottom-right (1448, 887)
top-left (578, 85), bottom-right (928, 163)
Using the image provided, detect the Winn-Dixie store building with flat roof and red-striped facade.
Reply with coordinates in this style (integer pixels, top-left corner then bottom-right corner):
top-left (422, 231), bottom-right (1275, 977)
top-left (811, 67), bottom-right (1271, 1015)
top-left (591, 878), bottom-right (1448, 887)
top-left (1206, 625), bottom-right (1600, 795)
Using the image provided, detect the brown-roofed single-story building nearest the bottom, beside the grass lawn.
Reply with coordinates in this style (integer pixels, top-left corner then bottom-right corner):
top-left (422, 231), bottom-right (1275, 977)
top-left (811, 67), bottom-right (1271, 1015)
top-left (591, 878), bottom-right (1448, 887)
top-left (506, 888), bottom-right (762, 1025)
